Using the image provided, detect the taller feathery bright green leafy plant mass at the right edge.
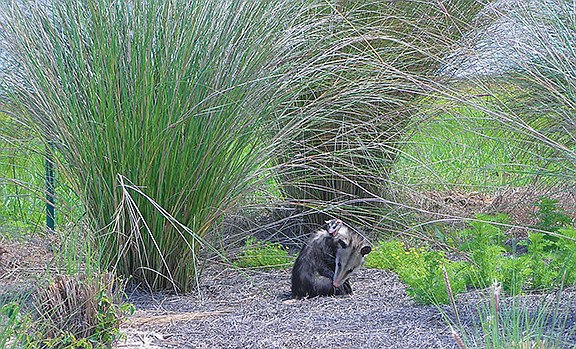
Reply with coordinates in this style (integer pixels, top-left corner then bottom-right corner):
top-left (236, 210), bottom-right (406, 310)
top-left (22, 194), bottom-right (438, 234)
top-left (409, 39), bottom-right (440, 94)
top-left (458, 208), bottom-right (574, 295)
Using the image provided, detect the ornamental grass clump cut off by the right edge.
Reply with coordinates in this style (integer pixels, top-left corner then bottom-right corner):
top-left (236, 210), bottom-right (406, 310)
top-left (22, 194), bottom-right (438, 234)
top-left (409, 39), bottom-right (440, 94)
top-left (467, 0), bottom-right (576, 188)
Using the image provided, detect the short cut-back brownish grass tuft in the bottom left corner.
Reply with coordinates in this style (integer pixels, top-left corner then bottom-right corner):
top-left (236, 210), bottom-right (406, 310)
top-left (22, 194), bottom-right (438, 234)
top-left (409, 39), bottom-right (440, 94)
top-left (28, 273), bottom-right (134, 348)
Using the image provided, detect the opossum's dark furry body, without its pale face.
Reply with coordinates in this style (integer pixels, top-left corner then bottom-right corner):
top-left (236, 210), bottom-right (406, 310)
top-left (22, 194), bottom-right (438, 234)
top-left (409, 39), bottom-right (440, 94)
top-left (292, 229), bottom-right (352, 298)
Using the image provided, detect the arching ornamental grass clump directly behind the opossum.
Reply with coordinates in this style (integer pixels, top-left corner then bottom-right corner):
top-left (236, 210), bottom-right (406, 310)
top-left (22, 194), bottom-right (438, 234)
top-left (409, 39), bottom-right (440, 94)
top-left (278, 0), bottom-right (486, 225)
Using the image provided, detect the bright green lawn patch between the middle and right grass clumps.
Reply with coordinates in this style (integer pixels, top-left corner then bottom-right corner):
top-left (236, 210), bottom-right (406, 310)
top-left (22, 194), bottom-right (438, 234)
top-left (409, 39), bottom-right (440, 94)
top-left (394, 107), bottom-right (562, 190)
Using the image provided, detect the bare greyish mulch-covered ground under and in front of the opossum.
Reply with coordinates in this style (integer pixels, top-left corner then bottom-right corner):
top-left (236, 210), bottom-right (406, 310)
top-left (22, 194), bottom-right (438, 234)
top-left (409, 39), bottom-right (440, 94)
top-left (120, 269), bottom-right (464, 348)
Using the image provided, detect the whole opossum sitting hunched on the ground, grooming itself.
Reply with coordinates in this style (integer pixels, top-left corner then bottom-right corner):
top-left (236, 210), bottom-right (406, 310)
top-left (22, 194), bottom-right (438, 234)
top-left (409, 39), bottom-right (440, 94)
top-left (292, 219), bottom-right (371, 298)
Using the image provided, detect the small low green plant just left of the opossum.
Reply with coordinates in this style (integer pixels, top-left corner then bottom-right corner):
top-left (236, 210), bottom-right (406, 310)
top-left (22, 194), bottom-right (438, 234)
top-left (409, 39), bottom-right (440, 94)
top-left (235, 238), bottom-right (294, 268)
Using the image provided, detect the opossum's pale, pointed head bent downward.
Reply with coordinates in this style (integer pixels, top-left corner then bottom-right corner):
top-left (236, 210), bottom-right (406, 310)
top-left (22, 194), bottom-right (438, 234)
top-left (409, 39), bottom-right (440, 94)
top-left (332, 232), bottom-right (372, 287)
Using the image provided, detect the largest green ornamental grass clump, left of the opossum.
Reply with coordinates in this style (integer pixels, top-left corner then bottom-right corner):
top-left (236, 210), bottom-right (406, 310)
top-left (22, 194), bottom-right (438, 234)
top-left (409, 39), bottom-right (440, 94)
top-left (0, 0), bottom-right (310, 291)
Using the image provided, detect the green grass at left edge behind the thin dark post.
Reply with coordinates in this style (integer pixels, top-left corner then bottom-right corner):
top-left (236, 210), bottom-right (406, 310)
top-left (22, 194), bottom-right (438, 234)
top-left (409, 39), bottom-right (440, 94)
top-left (0, 113), bottom-right (83, 238)
